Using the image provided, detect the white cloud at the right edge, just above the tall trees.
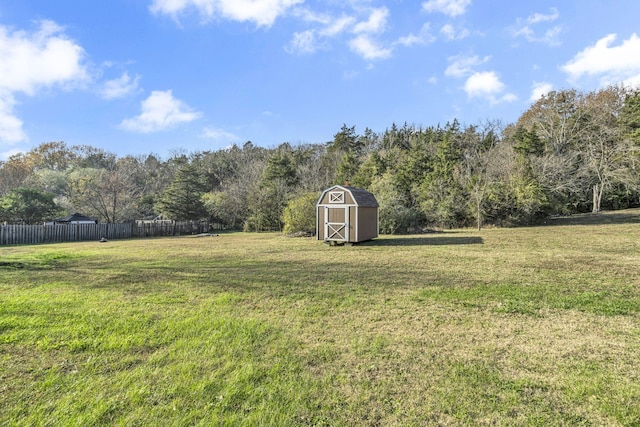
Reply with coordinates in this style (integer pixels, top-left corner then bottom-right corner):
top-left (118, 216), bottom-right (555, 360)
top-left (561, 33), bottom-right (640, 86)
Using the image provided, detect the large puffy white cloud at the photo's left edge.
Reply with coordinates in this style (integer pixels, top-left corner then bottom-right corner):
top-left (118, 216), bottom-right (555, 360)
top-left (0, 21), bottom-right (89, 145)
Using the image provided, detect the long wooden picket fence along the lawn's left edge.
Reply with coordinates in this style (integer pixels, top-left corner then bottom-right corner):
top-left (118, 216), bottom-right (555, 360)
top-left (0, 222), bottom-right (215, 245)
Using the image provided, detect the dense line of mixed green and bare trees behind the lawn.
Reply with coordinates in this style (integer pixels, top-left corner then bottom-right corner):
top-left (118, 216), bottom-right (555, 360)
top-left (0, 86), bottom-right (640, 233)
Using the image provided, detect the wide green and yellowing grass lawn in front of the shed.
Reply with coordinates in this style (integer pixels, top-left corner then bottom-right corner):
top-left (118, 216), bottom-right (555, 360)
top-left (0, 211), bottom-right (640, 426)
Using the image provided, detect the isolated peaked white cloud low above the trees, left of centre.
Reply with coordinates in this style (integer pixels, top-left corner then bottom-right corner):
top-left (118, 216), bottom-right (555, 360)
top-left (120, 90), bottom-right (202, 133)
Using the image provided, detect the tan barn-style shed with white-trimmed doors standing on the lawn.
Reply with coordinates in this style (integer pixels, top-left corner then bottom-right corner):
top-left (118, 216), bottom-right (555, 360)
top-left (316, 185), bottom-right (379, 243)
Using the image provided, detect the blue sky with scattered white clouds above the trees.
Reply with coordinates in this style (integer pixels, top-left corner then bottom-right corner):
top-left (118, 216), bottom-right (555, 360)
top-left (0, 0), bottom-right (640, 161)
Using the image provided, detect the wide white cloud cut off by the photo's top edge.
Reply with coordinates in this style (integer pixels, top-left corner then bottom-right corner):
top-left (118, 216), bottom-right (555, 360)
top-left (149, 0), bottom-right (304, 27)
